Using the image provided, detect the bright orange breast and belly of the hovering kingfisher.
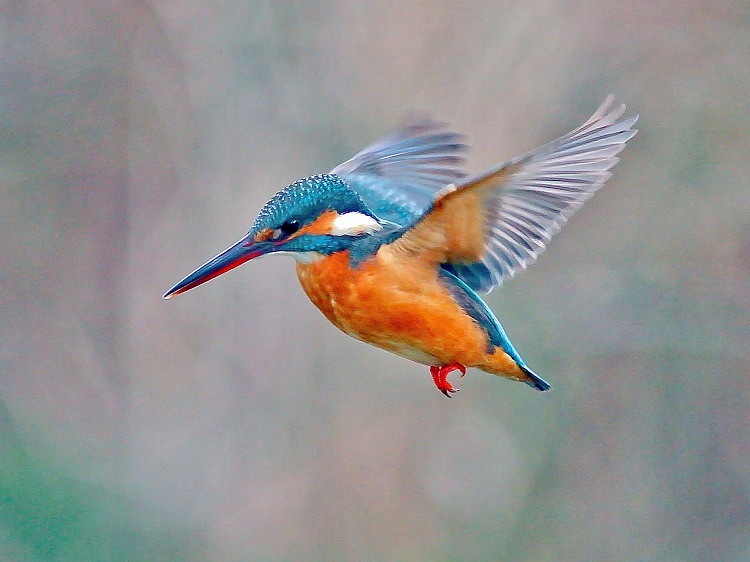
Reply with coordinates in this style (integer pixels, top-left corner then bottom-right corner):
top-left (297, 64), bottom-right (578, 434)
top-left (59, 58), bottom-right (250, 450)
top-left (297, 246), bottom-right (496, 367)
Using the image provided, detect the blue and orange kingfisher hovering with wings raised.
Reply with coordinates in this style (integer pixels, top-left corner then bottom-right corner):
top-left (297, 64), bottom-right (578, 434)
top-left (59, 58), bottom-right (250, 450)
top-left (164, 95), bottom-right (638, 398)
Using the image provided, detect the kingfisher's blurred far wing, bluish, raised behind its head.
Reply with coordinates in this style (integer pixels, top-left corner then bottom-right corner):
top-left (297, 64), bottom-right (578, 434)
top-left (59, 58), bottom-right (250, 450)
top-left (331, 116), bottom-right (468, 226)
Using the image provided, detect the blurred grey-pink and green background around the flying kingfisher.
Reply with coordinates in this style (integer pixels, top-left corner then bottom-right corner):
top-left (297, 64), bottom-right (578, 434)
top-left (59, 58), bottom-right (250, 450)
top-left (0, 0), bottom-right (750, 561)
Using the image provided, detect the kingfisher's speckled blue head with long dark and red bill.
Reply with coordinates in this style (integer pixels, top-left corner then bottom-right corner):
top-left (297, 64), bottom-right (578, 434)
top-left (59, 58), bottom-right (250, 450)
top-left (164, 174), bottom-right (382, 299)
